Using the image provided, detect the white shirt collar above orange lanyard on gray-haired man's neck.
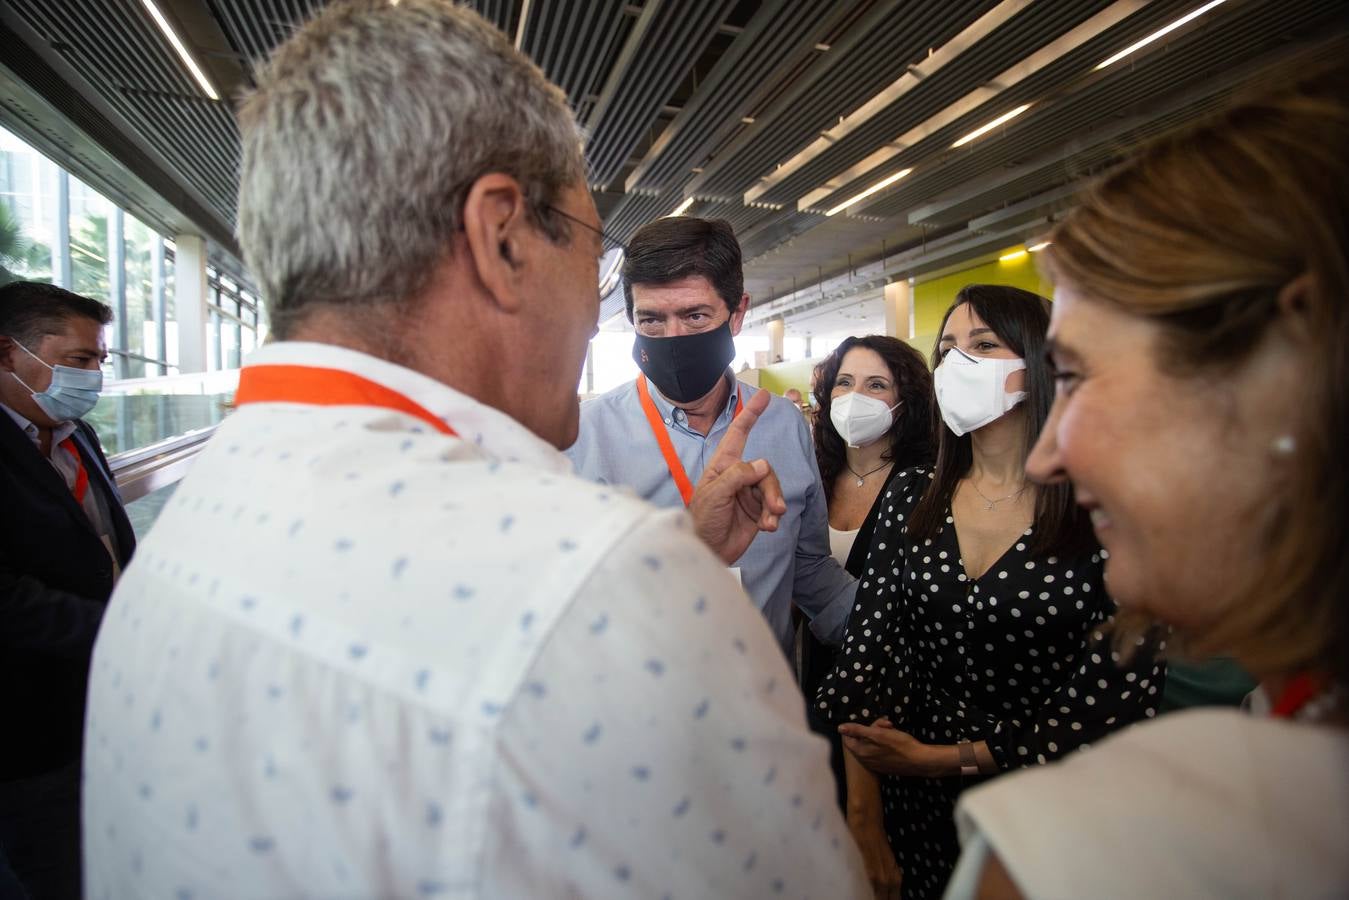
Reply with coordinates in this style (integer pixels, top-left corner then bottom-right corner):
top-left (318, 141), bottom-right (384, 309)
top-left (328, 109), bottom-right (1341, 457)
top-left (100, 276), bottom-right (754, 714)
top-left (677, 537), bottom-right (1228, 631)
top-left (244, 341), bottom-right (572, 474)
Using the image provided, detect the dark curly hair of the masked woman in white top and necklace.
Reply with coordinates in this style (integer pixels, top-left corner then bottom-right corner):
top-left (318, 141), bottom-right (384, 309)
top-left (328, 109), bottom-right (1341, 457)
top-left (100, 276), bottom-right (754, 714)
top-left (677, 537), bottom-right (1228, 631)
top-left (812, 335), bottom-right (934, 503)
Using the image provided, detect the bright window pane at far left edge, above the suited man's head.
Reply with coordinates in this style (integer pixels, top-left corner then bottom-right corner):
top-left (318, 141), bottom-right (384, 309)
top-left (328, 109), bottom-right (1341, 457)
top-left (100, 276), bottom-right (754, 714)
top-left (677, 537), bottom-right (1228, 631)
top-left (0, 128), bottom-right (59, 283)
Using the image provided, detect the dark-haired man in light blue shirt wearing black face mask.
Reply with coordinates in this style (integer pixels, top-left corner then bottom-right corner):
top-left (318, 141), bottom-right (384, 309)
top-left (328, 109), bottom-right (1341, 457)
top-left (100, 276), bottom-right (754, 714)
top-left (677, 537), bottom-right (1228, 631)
top-left (568, 217), bottom-right (855, 657)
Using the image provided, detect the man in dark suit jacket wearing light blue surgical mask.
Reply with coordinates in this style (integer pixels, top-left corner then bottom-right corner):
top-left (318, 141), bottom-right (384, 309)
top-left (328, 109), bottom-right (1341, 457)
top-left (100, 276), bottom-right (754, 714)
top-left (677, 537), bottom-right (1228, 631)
top-left (0, 282), bottom-right (135, 900)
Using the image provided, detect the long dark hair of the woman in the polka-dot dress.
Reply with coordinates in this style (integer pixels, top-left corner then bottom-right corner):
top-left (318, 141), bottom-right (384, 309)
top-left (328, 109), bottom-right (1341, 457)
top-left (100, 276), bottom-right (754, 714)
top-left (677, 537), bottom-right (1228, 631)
top-left (909, 285), bottom-right (1095, 556)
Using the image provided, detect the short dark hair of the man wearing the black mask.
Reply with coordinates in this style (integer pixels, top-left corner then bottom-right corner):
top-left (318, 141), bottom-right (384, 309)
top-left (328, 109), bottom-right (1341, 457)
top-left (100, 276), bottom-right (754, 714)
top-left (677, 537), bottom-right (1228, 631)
top-left (623, 216), bottom-right (745, 321)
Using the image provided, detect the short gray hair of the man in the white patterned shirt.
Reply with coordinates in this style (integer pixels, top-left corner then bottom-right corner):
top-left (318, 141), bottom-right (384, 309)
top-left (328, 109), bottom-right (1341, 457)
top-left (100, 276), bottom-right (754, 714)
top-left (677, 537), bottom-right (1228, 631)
top-left (237, 0), bottom-right (585, 337)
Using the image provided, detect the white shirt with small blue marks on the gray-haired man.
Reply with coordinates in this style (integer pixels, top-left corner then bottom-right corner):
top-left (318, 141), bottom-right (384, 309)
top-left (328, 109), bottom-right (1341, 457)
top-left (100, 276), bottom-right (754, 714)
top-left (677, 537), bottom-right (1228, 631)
top-left (84, 343), bottom-right (869, 900)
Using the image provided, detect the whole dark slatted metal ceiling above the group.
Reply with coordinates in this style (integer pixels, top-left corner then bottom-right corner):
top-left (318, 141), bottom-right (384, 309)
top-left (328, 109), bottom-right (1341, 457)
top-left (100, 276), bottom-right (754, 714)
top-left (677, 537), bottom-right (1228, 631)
top-left (0, 0), bottom-right (1349, 323)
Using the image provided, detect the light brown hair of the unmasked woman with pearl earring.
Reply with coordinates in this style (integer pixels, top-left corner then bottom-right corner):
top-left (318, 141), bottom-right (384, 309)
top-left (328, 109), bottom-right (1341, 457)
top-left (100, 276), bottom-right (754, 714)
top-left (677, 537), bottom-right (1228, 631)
top-left (1045, 56), bottom-right (1349, 684)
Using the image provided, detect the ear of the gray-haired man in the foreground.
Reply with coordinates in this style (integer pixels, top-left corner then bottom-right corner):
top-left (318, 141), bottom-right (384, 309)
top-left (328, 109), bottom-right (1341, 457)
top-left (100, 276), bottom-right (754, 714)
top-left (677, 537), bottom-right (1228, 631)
top-left (464, 171), bottom-right (529, 313)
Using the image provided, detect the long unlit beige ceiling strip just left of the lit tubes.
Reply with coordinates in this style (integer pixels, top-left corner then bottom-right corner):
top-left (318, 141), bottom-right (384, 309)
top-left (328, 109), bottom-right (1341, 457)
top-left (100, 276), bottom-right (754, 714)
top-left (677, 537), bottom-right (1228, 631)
top-left (796, 0), bottom-right (1151, 212)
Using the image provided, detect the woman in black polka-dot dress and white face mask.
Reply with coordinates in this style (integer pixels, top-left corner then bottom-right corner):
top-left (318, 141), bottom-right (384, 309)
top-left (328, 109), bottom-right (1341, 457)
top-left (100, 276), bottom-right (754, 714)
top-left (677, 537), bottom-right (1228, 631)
top-left (812, 285), bottom-right (1164, 897)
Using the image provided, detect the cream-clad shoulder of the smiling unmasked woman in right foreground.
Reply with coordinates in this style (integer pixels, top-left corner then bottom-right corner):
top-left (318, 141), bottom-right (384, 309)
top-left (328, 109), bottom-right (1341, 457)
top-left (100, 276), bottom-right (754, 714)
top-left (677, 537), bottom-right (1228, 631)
top-left (956, 710), bottom-right (1349, 896)
